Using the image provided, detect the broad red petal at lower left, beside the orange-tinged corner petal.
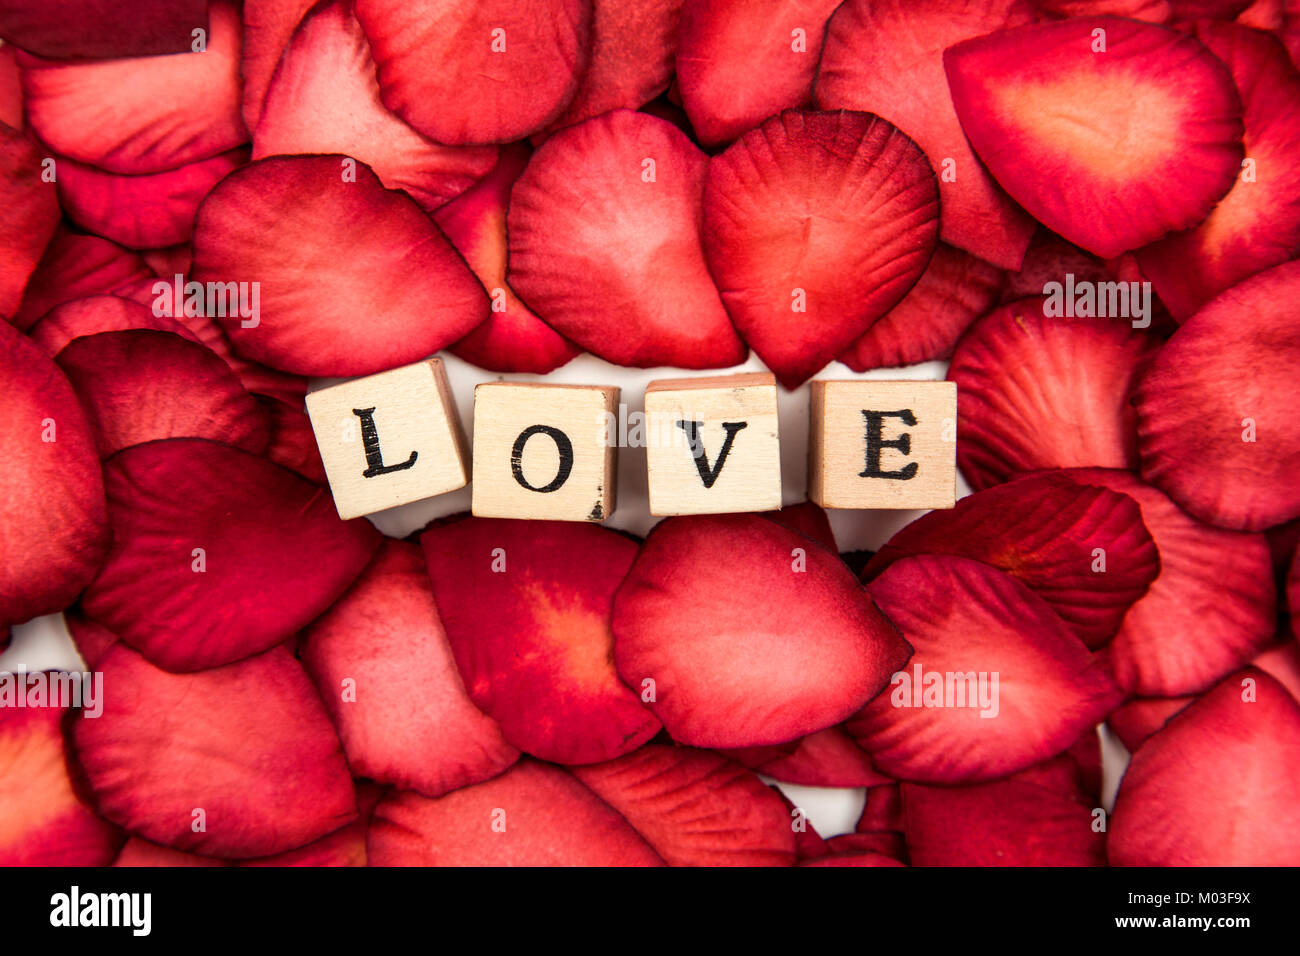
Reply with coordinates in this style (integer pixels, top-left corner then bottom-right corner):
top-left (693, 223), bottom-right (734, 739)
top-left (73, 644), bottom-right (356, 857)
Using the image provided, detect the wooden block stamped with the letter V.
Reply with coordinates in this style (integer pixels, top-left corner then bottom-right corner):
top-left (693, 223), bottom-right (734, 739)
top-left (646, 372), bottom-right (781, 515)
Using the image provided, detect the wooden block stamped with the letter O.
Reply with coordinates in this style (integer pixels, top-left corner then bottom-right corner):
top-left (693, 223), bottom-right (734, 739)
top-left (471, 382), bottom-right (619, 522)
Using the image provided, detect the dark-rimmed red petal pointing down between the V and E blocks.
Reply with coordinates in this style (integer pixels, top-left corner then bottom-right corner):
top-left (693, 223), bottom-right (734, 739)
top-left (703, 111), bottom-right (939, 389)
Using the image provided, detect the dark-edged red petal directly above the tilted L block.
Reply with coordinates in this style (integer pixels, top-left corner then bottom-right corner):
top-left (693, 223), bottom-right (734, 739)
top-left (192, 156), bottom-right (488, 376)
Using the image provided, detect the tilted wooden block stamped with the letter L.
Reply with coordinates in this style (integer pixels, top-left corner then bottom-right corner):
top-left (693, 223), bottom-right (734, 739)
top-left (307, 359), bottom-right (469, 519)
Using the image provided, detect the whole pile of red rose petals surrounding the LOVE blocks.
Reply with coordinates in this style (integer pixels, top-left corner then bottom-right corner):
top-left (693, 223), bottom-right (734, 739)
top-left (0, 0), bottom-right (1300, 866)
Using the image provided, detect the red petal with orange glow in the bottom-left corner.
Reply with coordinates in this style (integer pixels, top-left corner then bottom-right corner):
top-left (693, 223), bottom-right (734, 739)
top-left (0, 702), bottom-right (121, 866)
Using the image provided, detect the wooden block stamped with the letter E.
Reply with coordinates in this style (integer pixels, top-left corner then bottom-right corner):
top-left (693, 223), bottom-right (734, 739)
top-left (809, 381), bottom-right (957, 509)
